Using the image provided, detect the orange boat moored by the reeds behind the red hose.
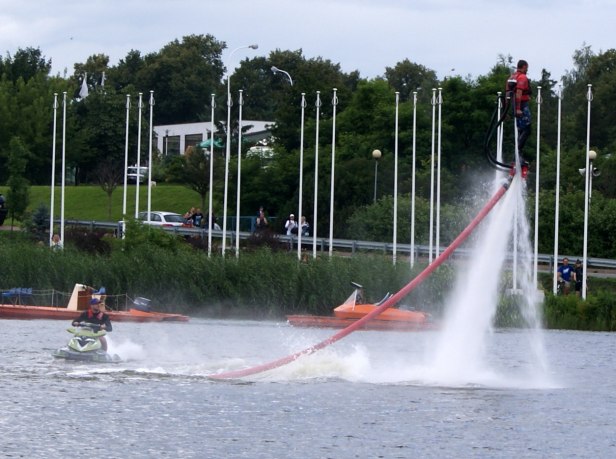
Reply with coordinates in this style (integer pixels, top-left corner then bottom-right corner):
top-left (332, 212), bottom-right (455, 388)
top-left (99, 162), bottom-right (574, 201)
top-left (287, 283), bottom-right (435, 331)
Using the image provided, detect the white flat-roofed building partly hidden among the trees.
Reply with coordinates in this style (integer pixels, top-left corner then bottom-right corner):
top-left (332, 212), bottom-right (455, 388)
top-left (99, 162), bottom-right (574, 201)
top-left (154, 120), bottom-right (274, 156)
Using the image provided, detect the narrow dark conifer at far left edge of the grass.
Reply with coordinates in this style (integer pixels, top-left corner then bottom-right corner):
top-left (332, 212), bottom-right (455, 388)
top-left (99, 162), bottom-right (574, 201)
top-left (7, 137), bottom-right (30, 225)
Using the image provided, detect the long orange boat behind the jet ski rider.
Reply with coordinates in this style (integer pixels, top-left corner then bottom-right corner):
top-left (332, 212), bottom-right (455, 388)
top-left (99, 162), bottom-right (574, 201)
top-left (0, 284), bottom-right (189, 322)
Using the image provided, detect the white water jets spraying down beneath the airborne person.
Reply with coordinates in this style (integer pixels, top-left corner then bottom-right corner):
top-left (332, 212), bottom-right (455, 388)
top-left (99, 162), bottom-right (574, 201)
top-left (418, 174), bottom-right (546, 385)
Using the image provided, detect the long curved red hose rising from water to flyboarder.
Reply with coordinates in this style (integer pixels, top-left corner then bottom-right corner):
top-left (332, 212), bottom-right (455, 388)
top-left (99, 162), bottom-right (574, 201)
top-left (209, 182), bottom-right (510, 379)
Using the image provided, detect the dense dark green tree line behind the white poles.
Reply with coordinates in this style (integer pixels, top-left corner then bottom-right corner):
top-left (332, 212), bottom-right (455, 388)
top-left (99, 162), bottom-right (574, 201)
top-left (0, 35), bottom-right (616, 257)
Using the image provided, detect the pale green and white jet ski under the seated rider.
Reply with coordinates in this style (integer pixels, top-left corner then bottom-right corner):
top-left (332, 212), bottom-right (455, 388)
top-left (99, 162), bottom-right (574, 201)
top-left (52, 322), bottom-right (122, 363)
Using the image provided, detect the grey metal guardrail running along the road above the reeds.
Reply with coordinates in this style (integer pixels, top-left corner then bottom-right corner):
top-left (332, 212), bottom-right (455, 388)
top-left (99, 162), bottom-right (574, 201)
top-left (57, 220), bottom-right (616, 269)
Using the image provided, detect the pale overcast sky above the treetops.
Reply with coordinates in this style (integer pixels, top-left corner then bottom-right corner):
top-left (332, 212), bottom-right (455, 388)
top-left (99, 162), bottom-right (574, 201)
top-left (0, 0), bottom-right (616, 80)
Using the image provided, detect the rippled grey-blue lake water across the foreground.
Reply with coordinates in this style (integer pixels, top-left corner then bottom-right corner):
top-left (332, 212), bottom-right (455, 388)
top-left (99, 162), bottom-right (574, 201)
top-left (0, 320), bottom-right (616, 458)
